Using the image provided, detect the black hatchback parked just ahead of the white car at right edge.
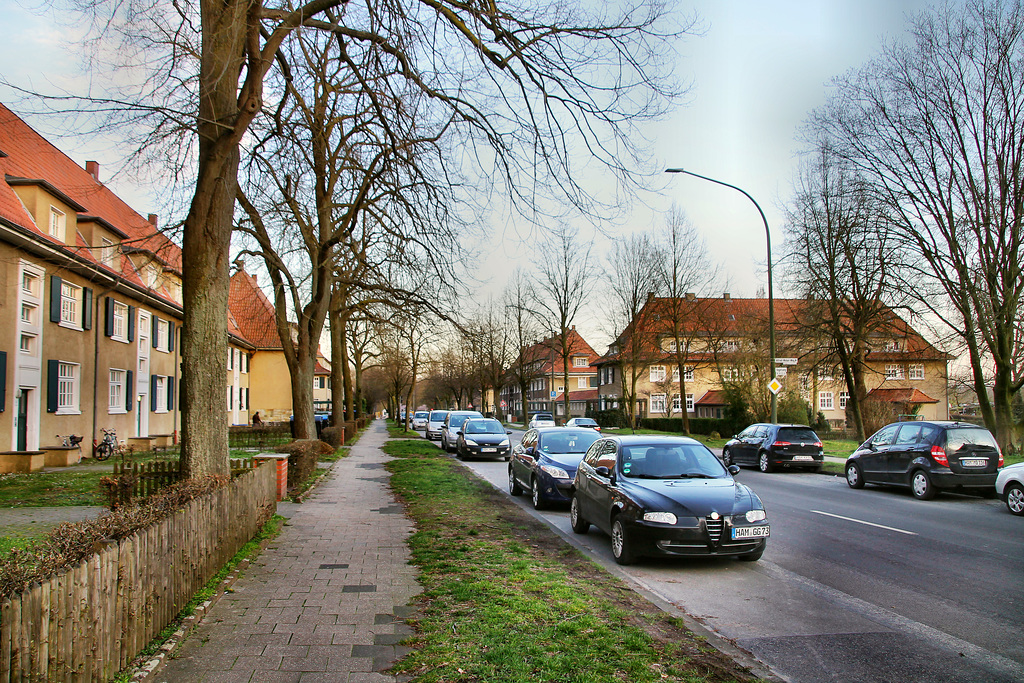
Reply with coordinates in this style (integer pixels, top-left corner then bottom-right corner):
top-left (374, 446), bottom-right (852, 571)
top-left (846, 421), bottom-right (1002, 501)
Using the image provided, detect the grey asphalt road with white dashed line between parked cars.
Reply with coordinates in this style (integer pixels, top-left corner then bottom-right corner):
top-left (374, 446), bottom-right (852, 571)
top-left (438, 432), bottom-right (1024, 683)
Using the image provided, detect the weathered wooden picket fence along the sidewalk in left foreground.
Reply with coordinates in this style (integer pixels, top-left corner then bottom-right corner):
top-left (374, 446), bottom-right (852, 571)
top-left (0, 464), bottom-right (276, 683)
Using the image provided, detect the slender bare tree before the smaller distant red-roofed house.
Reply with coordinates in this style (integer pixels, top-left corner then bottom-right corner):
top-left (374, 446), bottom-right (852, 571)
top-left (535, 225), bottom-right (594, 420)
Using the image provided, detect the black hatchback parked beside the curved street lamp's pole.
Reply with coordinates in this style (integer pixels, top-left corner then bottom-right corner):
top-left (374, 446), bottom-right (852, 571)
top-left (722, 423), bottom-right (825, 472)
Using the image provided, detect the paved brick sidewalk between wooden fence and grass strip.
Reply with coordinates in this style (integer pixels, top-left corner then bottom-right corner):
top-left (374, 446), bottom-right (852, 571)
top-left (151, 420), bottom-right (421, 683)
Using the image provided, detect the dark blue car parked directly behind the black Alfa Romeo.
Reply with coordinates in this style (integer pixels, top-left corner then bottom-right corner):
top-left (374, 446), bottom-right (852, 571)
top-left (509, 427), bottom-right (601, 510)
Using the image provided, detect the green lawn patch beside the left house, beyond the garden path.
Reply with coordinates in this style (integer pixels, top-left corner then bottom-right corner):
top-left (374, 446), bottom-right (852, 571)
top-left (0, 468), bottom-right (110, 508)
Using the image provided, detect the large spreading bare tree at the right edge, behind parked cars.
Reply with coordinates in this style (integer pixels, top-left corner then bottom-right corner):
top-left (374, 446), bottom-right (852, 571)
top-left (812, 0), bottom-right (1024, 447)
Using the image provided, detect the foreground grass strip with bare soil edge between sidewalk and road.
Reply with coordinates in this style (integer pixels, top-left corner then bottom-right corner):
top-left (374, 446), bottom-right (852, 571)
top-left (384, 439), bottom-right (756, 683)
